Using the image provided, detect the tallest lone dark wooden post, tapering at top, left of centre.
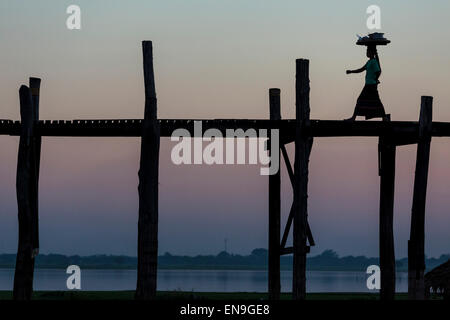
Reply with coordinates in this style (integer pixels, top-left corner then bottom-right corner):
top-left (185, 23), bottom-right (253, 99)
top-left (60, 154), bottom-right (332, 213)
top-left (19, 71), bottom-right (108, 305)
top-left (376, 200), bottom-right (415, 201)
top-left (135, 41), bottom-right (160, 300)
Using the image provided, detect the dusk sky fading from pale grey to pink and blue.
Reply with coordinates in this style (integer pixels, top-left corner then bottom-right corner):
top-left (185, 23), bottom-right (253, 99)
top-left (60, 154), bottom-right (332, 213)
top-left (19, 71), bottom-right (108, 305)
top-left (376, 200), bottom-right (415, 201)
top-left (0, 0), bottom-right (450, 257)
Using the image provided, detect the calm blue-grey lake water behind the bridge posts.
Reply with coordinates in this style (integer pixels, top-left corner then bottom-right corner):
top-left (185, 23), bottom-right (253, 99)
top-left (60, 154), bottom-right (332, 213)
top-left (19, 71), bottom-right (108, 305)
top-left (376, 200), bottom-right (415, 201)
top-left (0, 269), bottom-right (408, 292)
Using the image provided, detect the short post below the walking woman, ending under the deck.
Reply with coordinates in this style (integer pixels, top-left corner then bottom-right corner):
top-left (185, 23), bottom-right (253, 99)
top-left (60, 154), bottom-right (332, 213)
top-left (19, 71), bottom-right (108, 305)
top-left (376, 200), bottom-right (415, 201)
top-left (378, 136), bottom-right (396, 300)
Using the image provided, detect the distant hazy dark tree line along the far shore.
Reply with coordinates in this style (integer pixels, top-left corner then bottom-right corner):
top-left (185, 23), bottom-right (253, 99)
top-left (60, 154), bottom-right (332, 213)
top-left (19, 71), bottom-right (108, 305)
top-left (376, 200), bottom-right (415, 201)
top-left (0, 248), bottom-right (450, 271)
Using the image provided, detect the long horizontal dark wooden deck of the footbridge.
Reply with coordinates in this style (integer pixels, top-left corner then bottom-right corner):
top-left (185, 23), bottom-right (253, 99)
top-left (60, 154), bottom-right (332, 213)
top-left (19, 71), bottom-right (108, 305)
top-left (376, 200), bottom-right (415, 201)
top-left (0, 119), bottom-right (450, 142)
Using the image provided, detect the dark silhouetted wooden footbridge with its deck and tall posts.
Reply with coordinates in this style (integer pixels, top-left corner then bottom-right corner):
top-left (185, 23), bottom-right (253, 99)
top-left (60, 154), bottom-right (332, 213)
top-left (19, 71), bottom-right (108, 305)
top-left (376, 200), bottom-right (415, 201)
top-left (0, 41), bottom-right (442, 300)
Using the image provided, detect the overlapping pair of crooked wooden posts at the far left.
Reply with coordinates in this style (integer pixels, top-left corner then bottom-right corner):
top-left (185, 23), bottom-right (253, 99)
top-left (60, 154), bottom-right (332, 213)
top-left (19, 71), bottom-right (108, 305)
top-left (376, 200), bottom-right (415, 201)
top-left (13, 78), bottom-right (41, 300)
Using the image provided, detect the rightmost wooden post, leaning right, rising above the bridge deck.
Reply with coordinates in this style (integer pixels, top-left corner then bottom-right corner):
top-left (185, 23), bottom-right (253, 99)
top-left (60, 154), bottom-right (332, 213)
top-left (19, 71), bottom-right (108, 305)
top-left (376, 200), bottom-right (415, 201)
top-left (408, 97), bottom-right (433, 300)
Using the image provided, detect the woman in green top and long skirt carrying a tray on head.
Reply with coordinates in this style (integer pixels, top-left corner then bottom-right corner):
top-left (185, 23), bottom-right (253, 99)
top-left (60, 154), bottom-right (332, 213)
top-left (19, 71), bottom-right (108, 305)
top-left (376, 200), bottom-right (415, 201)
top-left (346, 45), bottom-right (388, 121)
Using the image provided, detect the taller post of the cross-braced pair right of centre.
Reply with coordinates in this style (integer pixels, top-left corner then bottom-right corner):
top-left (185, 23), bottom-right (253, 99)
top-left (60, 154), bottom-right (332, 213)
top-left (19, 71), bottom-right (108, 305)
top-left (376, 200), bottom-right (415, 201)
top-left (292, 59), bottom-right (313, 300)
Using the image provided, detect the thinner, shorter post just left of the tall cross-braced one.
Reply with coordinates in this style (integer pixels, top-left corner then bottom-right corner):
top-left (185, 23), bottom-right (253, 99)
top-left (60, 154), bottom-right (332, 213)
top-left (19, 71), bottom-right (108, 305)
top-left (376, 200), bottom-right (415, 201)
top-left (269, 89), bottom-right (281, 300)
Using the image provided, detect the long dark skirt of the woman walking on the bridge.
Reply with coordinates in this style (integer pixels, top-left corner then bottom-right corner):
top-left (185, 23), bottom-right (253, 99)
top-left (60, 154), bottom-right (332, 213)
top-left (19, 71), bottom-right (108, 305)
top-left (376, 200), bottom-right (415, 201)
top-left (355, 84), bottom-right (386, 120)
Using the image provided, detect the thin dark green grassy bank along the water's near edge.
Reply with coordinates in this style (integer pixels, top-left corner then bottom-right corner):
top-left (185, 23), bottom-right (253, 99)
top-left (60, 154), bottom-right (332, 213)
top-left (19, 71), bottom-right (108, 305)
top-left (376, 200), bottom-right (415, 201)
top-left (0, 291), bottom-right (438, 300)
